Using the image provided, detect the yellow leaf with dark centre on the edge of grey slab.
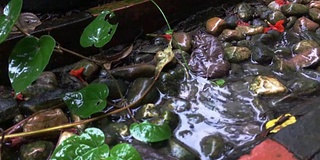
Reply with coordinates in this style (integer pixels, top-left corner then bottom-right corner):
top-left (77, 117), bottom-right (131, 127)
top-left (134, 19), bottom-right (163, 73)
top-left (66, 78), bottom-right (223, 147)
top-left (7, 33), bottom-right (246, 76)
top-left (266, 114), bottom-right (297, 133)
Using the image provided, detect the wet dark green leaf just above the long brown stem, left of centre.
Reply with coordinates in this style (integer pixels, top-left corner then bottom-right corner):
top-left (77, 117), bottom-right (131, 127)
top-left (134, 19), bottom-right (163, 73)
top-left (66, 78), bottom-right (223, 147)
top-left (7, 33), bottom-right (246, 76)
top-left (63, 83), bottom-right (109, 118)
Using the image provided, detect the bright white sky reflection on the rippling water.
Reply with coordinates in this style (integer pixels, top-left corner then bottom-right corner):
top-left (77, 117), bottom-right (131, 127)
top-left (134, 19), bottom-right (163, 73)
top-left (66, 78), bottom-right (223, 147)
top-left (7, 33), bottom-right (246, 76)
top-left (162, 73), bottom-right (263, 159)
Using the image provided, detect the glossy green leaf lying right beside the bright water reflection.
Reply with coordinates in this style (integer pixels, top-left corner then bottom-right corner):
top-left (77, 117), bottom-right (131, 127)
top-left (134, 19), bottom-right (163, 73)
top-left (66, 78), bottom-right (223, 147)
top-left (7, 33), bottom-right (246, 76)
top-left (130, 122), bottom-right (171, 142)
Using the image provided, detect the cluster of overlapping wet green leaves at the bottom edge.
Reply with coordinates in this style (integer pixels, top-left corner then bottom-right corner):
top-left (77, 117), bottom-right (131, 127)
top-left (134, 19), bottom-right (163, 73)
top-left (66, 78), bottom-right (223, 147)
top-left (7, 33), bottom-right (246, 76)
top-left (51, 128), bottom-right (141, 160)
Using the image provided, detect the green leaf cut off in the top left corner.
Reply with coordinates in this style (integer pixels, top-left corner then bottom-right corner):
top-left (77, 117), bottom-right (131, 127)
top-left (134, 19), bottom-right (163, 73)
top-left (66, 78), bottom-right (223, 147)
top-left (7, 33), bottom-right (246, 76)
top-left (0, 0), bottom-right (22, 43)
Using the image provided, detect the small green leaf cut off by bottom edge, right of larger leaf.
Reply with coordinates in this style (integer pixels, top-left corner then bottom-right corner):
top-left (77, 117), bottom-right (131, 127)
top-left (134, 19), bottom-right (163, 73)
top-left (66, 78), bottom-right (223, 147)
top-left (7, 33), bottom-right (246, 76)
top-left (110, 143), bottom-right (142, 160)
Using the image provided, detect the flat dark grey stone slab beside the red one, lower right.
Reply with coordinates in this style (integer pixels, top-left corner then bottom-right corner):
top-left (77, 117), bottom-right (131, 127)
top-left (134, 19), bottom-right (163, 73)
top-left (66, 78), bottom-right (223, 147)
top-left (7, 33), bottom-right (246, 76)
top-left (272, 100), bottom-right (320, 159)
